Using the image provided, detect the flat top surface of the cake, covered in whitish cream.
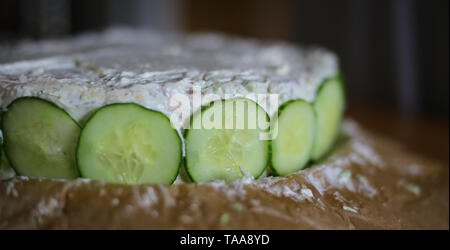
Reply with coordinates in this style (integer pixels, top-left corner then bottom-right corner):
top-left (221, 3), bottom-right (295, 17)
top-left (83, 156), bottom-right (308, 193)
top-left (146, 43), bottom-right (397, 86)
top-left (0, 29), bottom-right (338, 94)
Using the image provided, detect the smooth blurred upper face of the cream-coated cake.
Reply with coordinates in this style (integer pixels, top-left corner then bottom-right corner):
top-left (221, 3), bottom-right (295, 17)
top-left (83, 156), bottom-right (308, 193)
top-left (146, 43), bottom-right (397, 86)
top-left (0, 28), bottom-right (337, 78)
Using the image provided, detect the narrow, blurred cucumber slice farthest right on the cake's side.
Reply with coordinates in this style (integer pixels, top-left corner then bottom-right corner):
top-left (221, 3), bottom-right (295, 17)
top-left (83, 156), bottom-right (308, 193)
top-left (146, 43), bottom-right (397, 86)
top-left (312, 75), bottom-right (345, 161)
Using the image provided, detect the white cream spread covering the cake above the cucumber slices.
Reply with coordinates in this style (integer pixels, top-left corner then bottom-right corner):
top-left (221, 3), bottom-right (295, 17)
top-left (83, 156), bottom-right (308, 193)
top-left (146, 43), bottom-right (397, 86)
top-left (0, 29), bottom-right (339, 128)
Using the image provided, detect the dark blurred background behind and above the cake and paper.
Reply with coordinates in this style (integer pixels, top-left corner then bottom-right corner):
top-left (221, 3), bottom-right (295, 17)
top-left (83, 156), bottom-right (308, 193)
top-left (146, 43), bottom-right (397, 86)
top-left (0, 0), bottom-right (449, 163)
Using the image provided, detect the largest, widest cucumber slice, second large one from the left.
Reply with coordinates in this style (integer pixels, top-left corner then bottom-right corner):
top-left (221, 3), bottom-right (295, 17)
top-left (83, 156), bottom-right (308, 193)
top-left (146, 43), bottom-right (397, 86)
top-left (77, 103), bottom-right (182, 184)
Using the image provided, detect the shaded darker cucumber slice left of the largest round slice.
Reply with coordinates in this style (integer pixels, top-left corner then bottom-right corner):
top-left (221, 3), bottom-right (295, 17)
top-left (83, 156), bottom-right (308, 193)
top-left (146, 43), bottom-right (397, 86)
top-left (2, 97), bottom-right (80, 179)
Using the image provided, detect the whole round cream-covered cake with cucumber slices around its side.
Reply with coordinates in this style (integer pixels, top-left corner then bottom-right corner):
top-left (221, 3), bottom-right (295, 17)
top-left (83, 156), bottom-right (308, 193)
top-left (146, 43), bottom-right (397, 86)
top-left (0, 30), bottom-right (345, 183)
